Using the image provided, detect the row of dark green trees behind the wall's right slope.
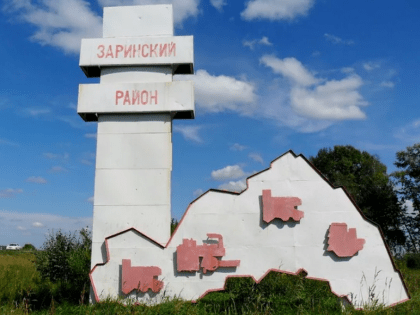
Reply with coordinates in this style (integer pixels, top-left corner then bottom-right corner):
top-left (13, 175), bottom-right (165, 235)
top-left (309, 143), bottom-right (420, 254)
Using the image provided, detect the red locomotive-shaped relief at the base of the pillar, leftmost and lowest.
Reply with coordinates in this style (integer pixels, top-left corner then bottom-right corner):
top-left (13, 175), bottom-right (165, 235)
top-left (122, 259), bottom-right (163, 294)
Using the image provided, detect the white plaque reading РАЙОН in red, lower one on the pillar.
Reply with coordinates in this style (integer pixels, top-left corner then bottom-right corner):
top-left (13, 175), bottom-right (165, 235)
top-left (77, 81), bottom-right (194, 120)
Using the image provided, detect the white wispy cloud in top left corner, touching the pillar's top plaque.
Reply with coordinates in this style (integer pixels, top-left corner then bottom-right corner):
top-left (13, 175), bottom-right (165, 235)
top-left (4, 0), bottom-right (102, 54)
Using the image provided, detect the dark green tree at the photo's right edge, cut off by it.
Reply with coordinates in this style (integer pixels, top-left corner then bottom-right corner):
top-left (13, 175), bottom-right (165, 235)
top-left (392, 143), bottom-right (420, 253)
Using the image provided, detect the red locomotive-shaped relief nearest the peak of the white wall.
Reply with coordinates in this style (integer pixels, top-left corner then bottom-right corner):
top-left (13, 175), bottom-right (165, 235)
top-left (262, 189), bottom-right (304, 223)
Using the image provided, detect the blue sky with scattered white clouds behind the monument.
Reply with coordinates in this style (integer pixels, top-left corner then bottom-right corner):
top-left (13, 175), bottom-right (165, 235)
top-left (0, 0), bottom-right (420, 247)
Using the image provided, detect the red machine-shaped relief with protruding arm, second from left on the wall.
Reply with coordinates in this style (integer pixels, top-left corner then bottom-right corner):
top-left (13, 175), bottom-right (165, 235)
top-left (176, 233), bottom-right (240, 273)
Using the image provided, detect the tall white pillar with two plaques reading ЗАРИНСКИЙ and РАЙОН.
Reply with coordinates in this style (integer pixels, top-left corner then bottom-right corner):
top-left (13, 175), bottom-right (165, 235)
top-left (78, 5), bottom-right (194, 268)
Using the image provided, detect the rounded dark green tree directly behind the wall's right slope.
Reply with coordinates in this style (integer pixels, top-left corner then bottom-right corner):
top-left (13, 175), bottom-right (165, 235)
top-left (309, 145), bottom-right (405, 249)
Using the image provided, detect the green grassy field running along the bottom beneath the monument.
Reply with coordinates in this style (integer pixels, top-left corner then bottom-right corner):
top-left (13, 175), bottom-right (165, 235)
top-left (0, 251), bottom-right (420, 314)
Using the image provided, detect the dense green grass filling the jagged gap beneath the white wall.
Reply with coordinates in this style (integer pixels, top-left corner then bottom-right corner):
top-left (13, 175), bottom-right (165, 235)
top-left (199, 272), bottom-right (341, 314)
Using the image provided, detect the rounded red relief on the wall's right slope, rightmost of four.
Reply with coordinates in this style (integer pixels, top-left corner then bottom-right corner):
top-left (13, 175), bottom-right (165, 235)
top-left (327, 223), bottom-right (365, 257)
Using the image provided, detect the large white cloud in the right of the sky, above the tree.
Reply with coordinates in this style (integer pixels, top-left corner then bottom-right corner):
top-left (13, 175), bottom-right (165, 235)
top-left (260, 55), bottom-right (368, 121)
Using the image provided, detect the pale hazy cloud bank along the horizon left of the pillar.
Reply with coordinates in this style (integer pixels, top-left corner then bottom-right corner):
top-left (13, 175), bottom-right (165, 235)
top-left (0, 210), bottom-right (92, 248)
